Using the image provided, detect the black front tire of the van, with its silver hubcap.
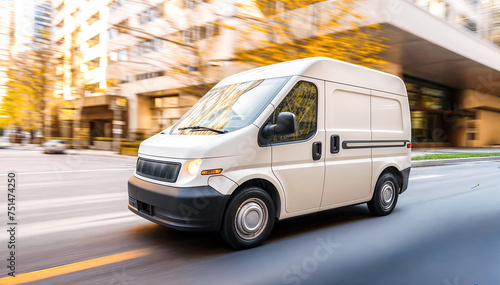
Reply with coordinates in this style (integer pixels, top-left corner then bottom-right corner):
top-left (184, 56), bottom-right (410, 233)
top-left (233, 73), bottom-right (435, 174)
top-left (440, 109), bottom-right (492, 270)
top-left (220, 186), bottom-right (276, 249)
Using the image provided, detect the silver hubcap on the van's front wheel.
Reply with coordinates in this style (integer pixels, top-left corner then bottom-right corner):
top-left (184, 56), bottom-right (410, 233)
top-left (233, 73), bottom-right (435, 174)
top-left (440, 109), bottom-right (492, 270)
top-left (234, 198), bottom-right (268, 240)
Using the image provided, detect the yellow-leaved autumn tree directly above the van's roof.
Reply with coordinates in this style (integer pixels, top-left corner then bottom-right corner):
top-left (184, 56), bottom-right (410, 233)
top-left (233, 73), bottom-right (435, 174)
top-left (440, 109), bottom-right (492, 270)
top-left (236, 0), bottom-right (387, 68)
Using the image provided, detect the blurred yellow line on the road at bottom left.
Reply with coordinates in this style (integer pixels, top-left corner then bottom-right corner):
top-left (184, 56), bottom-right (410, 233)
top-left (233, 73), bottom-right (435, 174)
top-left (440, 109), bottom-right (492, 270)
top-left (0, 248), bottom-right (151, 285)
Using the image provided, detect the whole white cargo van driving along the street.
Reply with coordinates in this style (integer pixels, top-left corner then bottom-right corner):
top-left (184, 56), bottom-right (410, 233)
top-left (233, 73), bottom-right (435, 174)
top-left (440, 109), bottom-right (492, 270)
top-left (128, 57), bottom-right (411, 249)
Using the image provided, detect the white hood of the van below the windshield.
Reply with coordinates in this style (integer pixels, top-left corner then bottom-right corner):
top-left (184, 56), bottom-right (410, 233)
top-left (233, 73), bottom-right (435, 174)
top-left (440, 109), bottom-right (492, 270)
top-left (139, 124), bottom-right (259, 159)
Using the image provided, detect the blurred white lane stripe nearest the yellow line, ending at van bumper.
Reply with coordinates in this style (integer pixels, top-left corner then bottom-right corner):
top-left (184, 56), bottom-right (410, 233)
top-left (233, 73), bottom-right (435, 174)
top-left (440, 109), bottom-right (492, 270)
top-left (1, 212), bottom-right (140, 237)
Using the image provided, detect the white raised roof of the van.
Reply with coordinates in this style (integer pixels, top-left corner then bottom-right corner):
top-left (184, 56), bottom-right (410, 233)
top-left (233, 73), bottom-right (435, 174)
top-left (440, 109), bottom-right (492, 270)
top-left (217, 57), bottom-right (406, 96)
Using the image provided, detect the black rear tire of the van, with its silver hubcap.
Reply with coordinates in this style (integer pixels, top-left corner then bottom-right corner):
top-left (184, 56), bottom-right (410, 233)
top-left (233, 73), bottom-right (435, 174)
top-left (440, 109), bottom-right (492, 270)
top-left (368, 172), bottom-right (399, 216)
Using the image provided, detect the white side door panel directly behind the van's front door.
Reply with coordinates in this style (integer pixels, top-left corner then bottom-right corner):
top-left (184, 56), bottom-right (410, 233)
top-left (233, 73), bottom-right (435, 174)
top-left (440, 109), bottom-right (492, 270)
top-left (321, 82), bottom-right (372, 209)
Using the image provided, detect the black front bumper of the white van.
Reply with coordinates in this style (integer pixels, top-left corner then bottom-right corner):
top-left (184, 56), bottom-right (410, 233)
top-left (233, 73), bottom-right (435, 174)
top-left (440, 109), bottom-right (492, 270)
top-left (128, 176), bottom-right (229, 231)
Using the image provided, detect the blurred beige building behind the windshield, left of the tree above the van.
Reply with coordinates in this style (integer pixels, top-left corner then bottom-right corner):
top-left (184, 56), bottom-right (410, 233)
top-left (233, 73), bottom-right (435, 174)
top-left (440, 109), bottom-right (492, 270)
top-left (108, 0), bottom-right (242, 139)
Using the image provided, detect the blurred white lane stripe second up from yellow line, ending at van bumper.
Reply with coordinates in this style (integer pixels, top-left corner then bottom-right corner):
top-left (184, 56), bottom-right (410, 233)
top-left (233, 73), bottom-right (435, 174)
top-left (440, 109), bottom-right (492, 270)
top-left (0, 192), bottom-right (128, 212)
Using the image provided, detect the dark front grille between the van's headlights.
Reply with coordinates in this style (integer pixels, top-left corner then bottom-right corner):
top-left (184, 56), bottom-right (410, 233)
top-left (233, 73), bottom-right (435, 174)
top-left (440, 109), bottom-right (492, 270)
top-left (135, 158), bottom-right (181, 182)
